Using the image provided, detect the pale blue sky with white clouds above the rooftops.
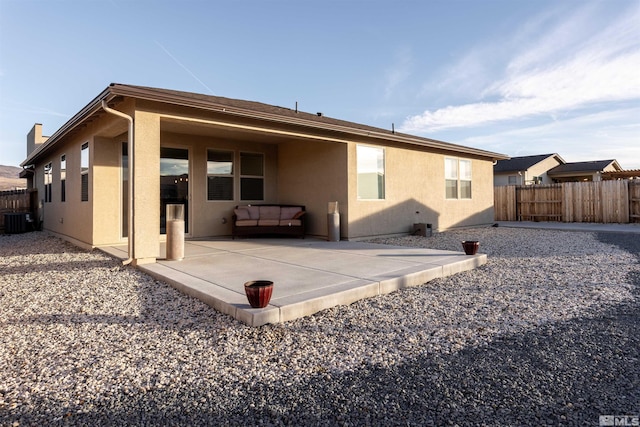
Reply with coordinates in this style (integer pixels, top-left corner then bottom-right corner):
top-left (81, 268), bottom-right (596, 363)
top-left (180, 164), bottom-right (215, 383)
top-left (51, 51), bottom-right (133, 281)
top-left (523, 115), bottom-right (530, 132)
top-left (0, 0), bottom-right (640, 169)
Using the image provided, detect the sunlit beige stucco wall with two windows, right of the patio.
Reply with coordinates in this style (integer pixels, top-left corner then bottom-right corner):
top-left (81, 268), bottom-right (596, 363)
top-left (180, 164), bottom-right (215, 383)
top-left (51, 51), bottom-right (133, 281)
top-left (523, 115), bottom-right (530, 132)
top-left (348, 143), bottom-right (493, 239)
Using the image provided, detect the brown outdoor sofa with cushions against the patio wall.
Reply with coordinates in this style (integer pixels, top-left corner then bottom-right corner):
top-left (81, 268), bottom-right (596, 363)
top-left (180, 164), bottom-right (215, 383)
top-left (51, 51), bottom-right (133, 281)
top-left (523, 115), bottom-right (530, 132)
top-left (231, 204), bottom-right (306, 239)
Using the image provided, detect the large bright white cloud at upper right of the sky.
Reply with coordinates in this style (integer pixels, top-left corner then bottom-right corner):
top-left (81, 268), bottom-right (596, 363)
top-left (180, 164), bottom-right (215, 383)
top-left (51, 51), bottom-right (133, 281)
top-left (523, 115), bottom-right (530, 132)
top-left (401, 3), bottom-right (640, 133)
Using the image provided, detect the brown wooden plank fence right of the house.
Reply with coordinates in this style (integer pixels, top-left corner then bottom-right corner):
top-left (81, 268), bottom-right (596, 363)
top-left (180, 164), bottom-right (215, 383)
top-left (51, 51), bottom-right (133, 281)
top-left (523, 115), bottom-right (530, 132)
top-left (494, 180), bottom-right (640, 223)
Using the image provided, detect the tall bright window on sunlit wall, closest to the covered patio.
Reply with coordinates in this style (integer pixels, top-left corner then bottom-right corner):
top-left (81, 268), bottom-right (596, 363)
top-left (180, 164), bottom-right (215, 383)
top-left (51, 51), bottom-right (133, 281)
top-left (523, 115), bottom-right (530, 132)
top-left (356, 145), bottom-right (385, 200)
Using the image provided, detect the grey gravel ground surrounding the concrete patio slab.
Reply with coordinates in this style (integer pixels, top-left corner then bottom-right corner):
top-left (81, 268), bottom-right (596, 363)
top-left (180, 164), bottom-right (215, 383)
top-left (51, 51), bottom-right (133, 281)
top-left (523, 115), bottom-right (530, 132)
top-left (0, 227), bottom-right (640, 426)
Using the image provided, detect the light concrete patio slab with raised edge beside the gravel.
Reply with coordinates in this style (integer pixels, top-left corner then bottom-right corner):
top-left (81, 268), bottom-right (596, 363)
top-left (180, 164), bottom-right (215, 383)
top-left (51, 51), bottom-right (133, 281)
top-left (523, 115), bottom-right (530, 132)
top-left (101, 238), bottom-right (487, 326)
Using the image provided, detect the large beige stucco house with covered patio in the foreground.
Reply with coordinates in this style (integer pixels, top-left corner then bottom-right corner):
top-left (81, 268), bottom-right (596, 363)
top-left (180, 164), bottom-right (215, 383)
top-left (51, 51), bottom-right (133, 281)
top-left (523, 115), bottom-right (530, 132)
top-left (22, 84), bottom-right (507, 264)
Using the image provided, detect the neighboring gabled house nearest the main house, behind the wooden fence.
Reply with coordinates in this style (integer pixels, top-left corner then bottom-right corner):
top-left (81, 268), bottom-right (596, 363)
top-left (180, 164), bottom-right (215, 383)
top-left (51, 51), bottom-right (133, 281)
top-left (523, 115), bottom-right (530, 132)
top-left (493, 154), bottom-right (565, 186)
